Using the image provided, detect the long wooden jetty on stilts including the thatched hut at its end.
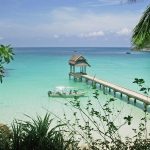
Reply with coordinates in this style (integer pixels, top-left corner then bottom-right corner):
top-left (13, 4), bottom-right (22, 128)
top-left (69, 55), bottom-right (150, 109)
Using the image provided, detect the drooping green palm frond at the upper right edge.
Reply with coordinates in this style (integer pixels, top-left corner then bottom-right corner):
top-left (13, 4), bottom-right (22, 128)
top-left (132, 6), bottom-right (150, 50)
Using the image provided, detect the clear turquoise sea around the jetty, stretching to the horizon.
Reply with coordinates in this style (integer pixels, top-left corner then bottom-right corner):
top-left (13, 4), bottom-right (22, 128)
top-left (0, 47), bottom-right (150, 137)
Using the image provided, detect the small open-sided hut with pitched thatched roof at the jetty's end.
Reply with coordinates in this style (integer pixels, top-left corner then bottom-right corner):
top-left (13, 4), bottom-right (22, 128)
top-left (69, 55), bottom-right (90, 74)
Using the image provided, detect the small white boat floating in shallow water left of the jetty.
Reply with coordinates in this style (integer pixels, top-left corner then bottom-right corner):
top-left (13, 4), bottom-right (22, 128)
top-left (48, 87), bottom-right (85, 98)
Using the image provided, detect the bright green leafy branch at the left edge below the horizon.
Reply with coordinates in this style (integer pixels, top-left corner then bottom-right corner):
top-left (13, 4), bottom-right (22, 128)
top-left (0, 45), bottom-right (14, 83)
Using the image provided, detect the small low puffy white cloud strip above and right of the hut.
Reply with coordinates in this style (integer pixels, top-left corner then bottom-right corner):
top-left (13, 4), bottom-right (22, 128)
top-left (80, 31), bottom-right (104, 38)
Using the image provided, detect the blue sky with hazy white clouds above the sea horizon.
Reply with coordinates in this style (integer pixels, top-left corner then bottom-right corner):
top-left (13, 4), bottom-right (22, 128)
top-left (0, 0), bottom-right (150, 47)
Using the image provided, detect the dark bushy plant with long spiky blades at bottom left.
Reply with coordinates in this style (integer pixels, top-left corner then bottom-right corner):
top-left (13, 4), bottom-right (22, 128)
top-left (11, 113), bottom-right (71, 150)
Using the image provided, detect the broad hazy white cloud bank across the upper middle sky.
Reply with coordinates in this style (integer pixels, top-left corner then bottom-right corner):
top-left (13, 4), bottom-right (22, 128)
top-left (46, 8), bottom-right (138, 35)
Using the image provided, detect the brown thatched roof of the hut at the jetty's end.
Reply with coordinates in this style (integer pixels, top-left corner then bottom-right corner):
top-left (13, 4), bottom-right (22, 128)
top-left (69, 55), bottom-right (90, 67)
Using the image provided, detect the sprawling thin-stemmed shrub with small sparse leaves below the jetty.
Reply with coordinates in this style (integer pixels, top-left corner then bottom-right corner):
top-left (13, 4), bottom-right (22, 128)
top-left (63, 90), bottom-right (132, 150)
